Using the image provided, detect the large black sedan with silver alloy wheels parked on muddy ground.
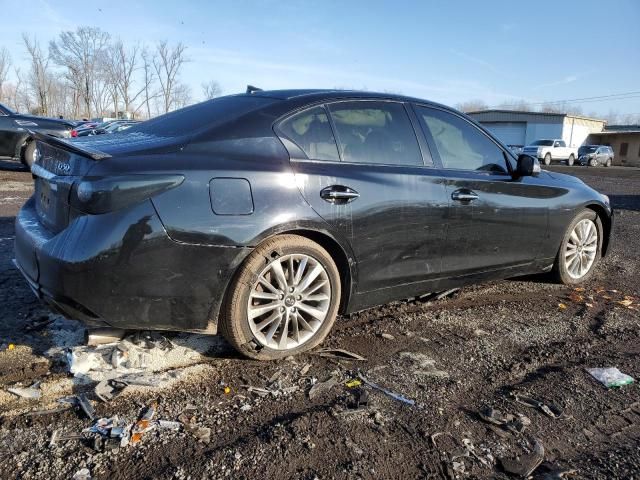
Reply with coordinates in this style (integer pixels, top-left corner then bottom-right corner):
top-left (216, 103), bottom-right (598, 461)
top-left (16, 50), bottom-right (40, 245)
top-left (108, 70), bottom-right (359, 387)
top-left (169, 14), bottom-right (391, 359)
top-left (15, 90), bottom-right (613, 359)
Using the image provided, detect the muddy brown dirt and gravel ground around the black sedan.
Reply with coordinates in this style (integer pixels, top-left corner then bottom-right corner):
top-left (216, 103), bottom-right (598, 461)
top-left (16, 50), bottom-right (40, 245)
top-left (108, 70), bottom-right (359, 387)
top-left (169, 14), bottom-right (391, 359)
top-left (0, 162), bottom-right (640, 480)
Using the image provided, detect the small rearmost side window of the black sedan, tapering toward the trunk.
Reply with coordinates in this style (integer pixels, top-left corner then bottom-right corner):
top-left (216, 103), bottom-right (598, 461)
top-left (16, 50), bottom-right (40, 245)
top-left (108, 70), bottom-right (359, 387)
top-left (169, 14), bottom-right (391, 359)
top-left (278, 107), bottom-right (340, 161)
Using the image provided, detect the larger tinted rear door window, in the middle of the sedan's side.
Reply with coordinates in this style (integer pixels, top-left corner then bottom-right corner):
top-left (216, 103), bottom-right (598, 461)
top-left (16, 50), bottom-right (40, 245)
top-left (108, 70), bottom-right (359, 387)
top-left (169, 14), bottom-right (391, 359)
top-left (329, 101), bottom-right (424, 166)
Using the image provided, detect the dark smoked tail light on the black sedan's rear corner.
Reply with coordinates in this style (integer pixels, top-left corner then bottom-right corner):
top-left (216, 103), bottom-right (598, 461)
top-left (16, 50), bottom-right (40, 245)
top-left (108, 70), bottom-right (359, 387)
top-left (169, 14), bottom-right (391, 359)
top-left (70, 174), bottom-right (184, 215)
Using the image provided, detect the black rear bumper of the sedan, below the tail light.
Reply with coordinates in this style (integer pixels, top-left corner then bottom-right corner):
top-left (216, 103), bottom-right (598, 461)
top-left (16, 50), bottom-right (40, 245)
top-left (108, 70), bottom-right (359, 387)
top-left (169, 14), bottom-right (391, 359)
top-left (15, 198), bottom-right (250, 333)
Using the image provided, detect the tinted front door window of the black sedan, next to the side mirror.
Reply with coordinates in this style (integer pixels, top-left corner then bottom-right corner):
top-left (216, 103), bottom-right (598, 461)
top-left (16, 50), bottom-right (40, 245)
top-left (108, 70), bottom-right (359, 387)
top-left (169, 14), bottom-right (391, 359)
top-left (417, 107), bottom-right (509, 174)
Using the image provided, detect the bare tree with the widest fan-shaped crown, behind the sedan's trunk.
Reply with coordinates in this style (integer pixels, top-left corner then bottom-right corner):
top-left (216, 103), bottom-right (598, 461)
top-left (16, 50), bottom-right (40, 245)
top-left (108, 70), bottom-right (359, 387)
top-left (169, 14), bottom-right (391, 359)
top-left (49, 27), bottom-right (109, 117)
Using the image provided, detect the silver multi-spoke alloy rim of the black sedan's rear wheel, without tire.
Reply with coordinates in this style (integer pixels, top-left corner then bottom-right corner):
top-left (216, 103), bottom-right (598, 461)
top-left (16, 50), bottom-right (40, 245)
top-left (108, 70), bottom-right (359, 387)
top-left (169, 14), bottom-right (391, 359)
top-left (247, 254), bottom-right (331, 350)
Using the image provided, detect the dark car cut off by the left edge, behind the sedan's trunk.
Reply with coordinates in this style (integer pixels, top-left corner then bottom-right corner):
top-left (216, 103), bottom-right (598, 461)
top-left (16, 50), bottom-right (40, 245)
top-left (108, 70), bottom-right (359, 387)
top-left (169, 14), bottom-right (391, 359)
top-left (0, 104), bottom-right (73, 167)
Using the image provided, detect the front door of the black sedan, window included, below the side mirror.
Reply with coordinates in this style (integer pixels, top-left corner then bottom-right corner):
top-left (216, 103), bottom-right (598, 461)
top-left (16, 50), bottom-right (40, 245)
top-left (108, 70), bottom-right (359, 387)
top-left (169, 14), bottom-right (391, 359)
top-left (416, 106), bottom-right (557, 276)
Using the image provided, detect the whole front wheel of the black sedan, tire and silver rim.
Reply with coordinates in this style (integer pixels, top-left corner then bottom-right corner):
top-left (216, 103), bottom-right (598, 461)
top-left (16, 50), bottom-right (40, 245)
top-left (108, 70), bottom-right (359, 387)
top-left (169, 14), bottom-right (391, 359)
top-left (554, 209), bottom-right (602, 285)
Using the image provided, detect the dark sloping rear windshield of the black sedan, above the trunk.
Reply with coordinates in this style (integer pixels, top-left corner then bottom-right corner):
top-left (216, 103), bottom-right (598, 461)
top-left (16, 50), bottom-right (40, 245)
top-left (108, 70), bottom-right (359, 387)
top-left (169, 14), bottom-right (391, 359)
top-left (127, 95), bottom-right (278, 137)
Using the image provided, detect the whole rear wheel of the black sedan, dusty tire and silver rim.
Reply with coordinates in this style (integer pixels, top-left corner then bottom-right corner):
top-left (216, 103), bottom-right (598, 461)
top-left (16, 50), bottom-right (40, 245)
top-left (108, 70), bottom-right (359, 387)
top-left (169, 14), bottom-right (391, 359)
top-left (220, 234), bottom-right (341, 360)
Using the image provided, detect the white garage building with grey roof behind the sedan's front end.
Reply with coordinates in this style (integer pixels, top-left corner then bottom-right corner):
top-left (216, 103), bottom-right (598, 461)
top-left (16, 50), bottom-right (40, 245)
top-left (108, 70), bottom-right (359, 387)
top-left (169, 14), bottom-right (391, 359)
top-left (467, 110), bottom-right (605, 147)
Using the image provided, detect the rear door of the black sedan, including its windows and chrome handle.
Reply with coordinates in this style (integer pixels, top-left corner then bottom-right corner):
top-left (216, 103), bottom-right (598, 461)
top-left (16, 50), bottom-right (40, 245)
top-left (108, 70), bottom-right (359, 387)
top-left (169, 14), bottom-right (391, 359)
top-left (279, 100), bottom-right (448, 292)
